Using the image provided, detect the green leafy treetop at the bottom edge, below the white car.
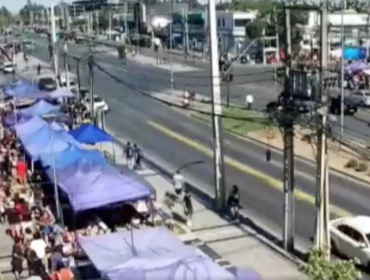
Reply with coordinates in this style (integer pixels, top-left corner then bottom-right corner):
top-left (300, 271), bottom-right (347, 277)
top-left (303, 249), bottom-right (362, 280)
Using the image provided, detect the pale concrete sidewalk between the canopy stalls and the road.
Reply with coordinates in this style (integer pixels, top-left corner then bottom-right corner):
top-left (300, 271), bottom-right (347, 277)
top-left (102, 139), bottom-right (307, 280)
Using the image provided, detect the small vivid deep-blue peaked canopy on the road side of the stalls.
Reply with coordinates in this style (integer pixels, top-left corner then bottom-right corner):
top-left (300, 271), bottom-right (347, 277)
top-left (69, 124), bottom-right (115, 145)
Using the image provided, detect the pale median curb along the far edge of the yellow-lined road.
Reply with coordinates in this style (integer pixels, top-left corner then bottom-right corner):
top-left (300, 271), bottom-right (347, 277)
top-left (190, 113), bottom-right (370, 188)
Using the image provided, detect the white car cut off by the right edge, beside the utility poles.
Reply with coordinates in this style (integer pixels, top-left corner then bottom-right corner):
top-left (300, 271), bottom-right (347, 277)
top-left (330, 216), bottom-right (370, 271)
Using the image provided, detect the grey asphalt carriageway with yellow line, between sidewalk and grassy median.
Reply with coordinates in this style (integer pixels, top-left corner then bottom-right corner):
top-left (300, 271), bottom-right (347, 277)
top-left (17, 32), bottom-right (370, 252)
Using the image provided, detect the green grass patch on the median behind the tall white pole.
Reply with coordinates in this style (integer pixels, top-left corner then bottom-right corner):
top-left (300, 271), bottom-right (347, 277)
top-left (192, 107), bottom-right (274, 136)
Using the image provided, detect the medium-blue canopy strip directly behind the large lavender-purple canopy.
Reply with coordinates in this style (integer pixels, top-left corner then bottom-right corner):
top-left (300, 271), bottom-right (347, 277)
top-left (40, 146), bottom-right (108, 169)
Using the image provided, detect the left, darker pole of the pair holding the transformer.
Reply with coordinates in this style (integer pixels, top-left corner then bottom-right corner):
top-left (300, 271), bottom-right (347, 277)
top-left (282, 7), bottom-right (294, 252)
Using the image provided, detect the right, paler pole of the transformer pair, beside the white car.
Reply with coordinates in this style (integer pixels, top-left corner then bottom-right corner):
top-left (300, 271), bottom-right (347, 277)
top-left (315, 5), bottom-right (330, 258)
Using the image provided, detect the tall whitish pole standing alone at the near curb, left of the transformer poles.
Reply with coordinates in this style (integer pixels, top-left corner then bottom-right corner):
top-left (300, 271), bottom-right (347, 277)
top-left (208, 0), bottom-right (226, 209)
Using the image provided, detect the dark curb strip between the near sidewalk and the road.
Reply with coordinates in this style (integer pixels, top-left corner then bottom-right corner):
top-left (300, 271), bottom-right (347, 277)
top-left (144, 154), bottom-right (307, 261)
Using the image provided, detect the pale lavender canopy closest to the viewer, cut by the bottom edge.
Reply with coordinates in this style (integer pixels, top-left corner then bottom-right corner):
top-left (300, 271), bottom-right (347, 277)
top-left (78, 227), bottom-right (235, 280)
